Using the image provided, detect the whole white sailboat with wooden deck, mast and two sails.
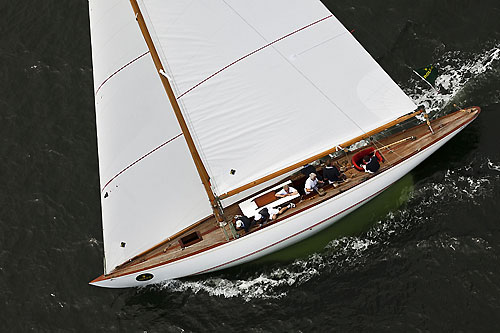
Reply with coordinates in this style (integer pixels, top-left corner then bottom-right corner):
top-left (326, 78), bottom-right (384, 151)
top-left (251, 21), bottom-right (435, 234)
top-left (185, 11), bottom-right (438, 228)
top-left (89, 0), bottom-right (480, 288)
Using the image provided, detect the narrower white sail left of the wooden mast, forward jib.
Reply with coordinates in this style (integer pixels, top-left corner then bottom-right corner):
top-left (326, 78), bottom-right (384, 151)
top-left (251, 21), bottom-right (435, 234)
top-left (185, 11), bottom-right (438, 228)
top-left (89, 0), bottom-right (211, 273)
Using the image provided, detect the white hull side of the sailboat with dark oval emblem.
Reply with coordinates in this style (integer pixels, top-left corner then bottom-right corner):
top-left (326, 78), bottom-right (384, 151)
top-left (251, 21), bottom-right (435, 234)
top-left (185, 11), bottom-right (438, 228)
top-left (92, 122), bottom-right (469, 288)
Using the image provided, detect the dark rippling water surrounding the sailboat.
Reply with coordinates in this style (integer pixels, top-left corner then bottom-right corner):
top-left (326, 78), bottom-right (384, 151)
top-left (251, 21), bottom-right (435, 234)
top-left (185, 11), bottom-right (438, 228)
top-left (0, 0), bottom-right (500, 332)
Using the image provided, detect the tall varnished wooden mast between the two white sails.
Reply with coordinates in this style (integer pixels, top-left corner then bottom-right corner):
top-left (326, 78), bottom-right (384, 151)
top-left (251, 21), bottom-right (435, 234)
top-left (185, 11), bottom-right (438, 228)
top-left (130, 0), bottom-right (222, 221)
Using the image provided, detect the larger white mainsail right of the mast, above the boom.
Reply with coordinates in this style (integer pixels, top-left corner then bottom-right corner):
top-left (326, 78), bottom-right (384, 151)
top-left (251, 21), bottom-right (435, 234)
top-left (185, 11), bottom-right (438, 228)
top-left (139, 0), bottom-right (416, 194)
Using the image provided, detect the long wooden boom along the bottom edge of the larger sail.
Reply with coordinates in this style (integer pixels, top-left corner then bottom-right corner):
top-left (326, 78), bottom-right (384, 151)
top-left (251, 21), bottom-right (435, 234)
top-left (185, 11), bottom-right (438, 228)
top-left (219, 109), bottom-right (424, 199)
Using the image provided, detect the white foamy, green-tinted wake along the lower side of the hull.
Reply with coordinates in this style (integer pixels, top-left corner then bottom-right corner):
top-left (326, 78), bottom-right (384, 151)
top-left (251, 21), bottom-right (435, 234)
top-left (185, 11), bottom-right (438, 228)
top-left (130, 98), bottom-right (498, 300)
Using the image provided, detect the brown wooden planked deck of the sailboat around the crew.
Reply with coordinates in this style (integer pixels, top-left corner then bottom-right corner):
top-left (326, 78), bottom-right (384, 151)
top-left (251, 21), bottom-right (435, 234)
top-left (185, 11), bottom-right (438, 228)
top-left (96, 108), bottom-right (479, 280)
